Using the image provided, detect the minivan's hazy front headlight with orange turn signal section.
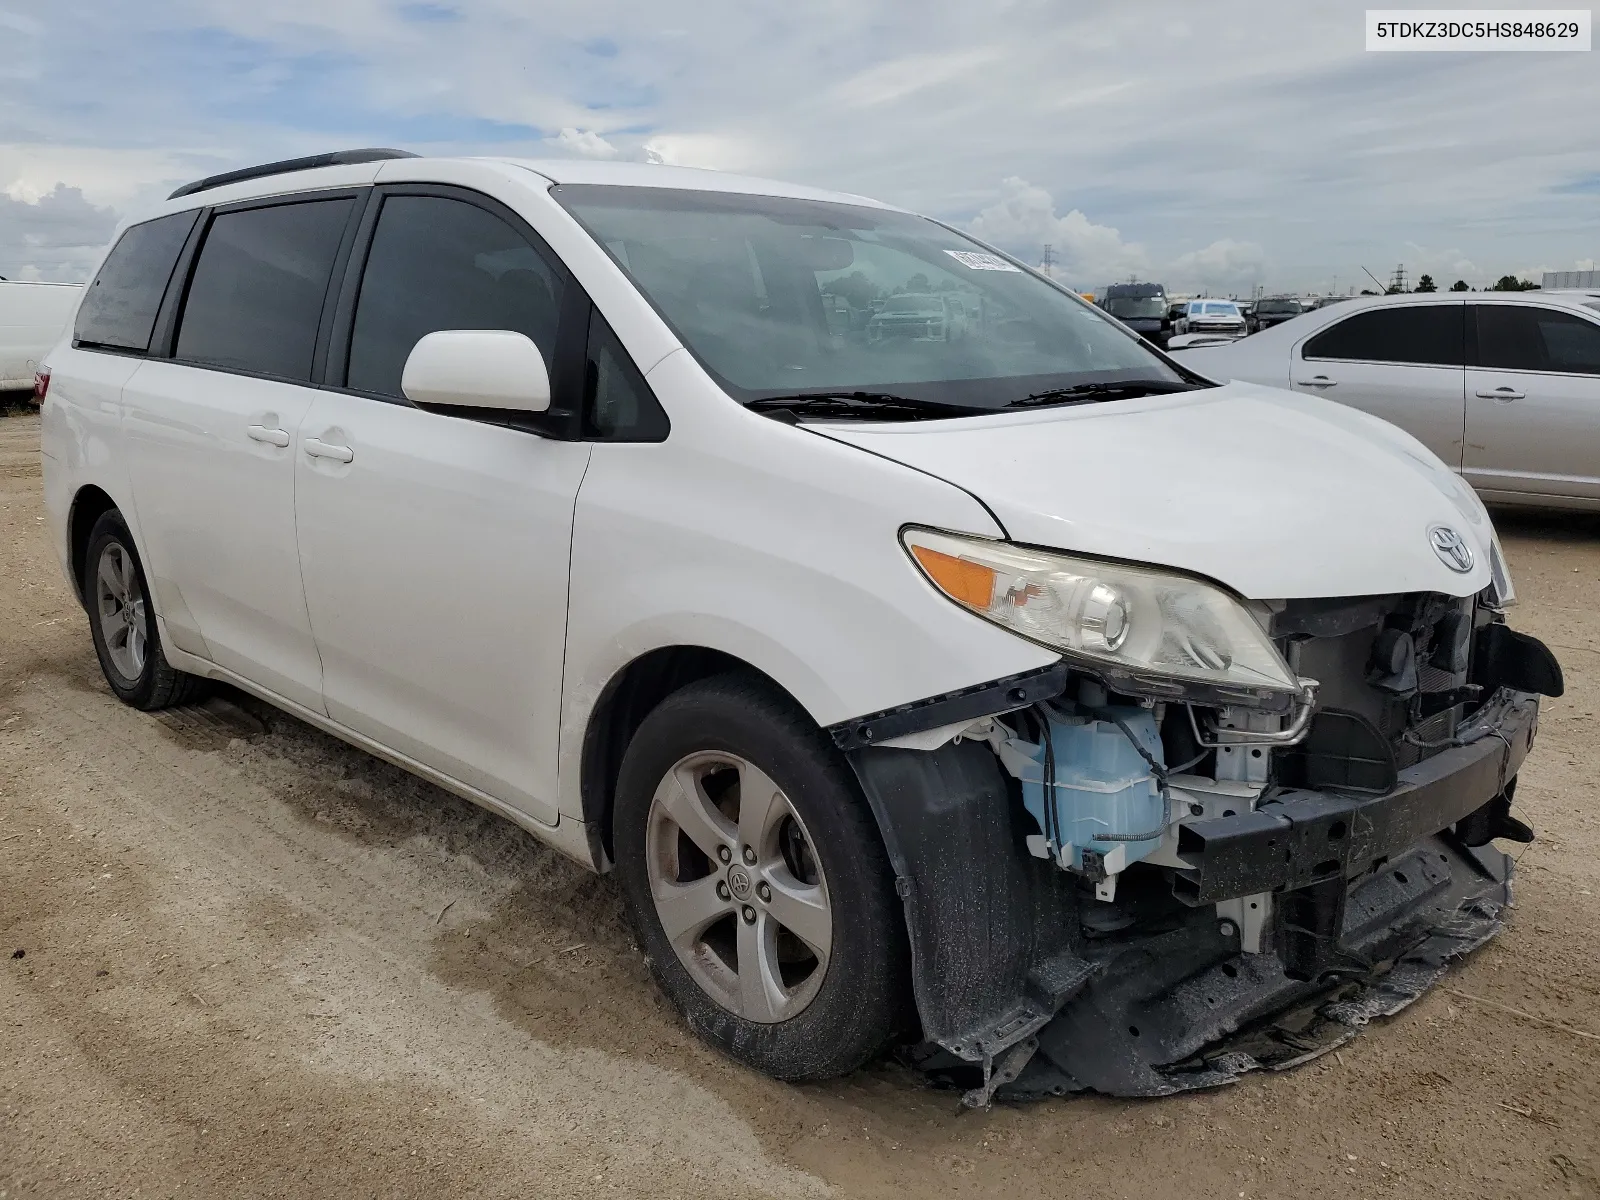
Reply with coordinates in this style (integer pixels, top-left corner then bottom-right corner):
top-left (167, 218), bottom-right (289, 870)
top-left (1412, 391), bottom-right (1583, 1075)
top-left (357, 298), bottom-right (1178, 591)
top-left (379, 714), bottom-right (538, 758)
top-left (901, 528), bottom-right (1301, 699)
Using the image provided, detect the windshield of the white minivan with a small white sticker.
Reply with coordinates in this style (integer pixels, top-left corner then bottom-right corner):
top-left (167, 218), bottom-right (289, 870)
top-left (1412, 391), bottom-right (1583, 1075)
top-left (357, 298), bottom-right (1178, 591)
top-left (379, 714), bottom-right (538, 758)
top-left (550, 184), bottom-right (1186, 408)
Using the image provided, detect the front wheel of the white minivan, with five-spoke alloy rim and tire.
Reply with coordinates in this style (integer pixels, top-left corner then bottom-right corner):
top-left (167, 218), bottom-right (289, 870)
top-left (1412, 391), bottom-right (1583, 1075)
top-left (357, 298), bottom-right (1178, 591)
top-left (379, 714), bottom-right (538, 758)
top-left (613, 675), bottom-right (909, 1080)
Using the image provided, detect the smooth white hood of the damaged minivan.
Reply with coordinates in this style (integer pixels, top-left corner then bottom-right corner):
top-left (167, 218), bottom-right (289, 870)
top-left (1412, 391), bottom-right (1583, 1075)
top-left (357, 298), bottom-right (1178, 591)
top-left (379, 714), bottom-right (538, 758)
top-left (808, 382), bottom-right (1493, 600)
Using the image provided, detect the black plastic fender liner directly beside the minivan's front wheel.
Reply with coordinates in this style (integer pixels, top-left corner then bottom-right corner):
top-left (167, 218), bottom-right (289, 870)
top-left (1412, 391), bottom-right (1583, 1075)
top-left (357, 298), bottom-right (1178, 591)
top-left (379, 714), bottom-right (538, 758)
top-left (850, 742), bottom-right (1098, 1062)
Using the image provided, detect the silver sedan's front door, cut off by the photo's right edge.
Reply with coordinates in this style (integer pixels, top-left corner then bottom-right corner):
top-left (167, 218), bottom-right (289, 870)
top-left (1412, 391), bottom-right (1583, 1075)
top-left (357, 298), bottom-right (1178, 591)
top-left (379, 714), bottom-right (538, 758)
top-left (1462, 302), bottom-right (1600, 501)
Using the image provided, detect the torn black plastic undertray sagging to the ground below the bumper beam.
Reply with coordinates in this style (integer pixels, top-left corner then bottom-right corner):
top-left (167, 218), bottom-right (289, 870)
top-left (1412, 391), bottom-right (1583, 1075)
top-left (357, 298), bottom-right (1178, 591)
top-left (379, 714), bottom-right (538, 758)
top-left (998, 834), bottom-right (1512, 1099)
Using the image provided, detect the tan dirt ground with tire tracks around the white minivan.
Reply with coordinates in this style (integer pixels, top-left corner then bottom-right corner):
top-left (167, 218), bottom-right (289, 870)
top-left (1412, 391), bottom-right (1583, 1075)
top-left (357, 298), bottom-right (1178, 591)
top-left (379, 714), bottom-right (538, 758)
top-left (0, 414), bottom-right (1600, 1200)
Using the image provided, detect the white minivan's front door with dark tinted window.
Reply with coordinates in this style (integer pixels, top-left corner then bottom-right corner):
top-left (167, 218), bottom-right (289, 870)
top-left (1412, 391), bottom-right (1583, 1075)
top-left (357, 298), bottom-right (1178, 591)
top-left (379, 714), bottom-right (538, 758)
top-left (296, 194), bottom-right (590, 824)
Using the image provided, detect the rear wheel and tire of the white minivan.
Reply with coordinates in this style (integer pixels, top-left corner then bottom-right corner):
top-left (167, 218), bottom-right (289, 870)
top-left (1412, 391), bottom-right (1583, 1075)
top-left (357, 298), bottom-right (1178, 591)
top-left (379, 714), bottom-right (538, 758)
top-left (83, 509), bottom-right (208, 712)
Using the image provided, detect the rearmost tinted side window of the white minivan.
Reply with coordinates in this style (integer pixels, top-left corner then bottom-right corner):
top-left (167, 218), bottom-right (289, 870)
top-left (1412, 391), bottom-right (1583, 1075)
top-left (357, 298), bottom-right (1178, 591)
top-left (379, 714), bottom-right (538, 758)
top-left (72, 210), bottom-right (200, 354)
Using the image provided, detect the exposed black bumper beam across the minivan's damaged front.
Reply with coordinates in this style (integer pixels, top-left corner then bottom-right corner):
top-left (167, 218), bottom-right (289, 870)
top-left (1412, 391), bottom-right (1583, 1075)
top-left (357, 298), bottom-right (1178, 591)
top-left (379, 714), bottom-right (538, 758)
top-left (1173, 690), bottom-right (1539, 904)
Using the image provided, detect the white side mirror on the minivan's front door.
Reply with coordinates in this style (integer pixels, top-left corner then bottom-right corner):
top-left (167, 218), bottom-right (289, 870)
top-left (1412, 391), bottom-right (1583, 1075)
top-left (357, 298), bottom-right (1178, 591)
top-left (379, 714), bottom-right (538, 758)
top-left (400, 330), bottom-right (550, 413)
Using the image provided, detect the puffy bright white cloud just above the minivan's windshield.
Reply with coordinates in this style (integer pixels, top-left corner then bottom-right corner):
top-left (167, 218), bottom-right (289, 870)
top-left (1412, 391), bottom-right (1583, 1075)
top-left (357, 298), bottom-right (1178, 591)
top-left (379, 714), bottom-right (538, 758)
top-left (966, 176), bottom-right (1150, 288)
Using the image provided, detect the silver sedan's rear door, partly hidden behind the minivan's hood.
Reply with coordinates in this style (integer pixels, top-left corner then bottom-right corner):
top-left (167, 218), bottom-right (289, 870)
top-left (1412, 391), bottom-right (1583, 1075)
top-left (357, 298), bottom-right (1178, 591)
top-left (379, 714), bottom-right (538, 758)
top-left (1290, 301), bottom-right (1466, 470)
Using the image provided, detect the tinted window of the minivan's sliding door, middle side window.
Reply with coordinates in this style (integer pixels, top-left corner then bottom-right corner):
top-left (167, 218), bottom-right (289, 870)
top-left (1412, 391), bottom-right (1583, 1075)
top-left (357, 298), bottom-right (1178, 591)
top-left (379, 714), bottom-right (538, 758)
top-left (178, 197), bottom-right (355, 381)
